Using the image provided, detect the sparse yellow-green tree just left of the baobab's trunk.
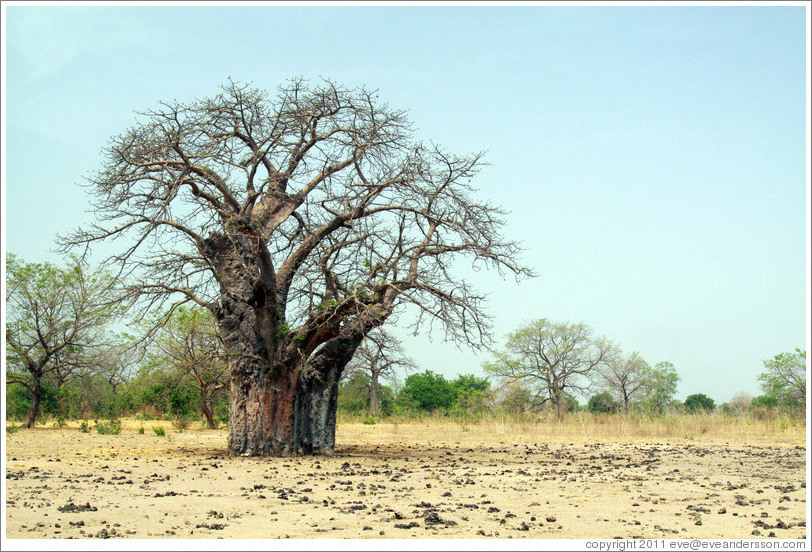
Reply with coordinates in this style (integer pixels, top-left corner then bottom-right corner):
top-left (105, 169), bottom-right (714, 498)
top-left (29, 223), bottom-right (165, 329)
top-left (156, 306), bottom-right (228, 429)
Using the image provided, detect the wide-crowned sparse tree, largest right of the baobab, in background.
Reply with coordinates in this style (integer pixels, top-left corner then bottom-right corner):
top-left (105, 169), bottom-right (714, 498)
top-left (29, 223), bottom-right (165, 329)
top-left (485, 319), bottom-right (613, 420)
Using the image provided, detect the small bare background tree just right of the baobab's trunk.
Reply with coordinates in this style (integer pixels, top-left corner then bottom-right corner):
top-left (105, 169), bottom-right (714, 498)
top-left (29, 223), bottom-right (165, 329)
top-left (342, 328), bottom-right (416, 416)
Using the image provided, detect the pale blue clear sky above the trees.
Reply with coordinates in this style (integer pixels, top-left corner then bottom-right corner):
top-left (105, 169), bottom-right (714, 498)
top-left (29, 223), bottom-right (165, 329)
top-left (3, 3), bottom-right (809, 403)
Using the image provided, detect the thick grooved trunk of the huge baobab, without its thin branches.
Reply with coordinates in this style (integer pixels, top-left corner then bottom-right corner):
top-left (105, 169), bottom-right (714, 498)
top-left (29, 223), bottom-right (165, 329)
top-left (207, 231), bottom-right (392, 456)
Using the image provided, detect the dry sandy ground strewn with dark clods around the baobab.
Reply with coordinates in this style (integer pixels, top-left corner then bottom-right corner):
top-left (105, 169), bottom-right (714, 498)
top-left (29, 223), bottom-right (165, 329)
top-left (5, 422), bottom-right (807, 539)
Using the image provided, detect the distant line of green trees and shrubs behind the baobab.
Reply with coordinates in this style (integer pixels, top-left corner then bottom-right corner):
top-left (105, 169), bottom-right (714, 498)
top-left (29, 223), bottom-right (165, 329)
top-left (5, 255), bottom-right (806, 428)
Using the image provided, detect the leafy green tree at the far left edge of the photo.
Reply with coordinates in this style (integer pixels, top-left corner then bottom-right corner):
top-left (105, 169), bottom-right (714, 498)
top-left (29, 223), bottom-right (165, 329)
top-left (6, 255), bottom-right (116, 428)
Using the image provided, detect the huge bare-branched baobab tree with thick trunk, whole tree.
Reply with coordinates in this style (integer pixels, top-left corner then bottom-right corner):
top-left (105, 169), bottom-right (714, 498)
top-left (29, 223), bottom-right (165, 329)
top-left (62, 79), bottom-right (531, 455)
